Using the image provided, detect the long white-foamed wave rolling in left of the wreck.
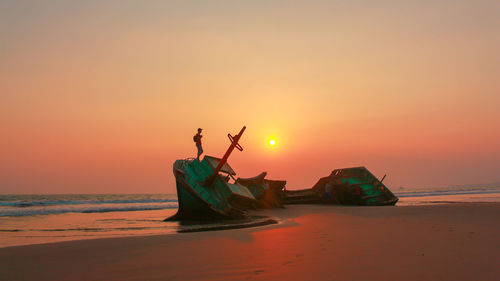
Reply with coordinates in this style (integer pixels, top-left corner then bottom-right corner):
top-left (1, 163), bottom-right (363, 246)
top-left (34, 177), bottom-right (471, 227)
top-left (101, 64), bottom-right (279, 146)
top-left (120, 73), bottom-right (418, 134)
top-left (0, 203), bottom-right (178, 217)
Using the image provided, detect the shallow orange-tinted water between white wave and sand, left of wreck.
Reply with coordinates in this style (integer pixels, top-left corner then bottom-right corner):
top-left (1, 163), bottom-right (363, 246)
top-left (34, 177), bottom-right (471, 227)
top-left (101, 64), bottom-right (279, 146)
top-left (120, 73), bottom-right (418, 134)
top-left (0, 209), bottom-right (179, 247)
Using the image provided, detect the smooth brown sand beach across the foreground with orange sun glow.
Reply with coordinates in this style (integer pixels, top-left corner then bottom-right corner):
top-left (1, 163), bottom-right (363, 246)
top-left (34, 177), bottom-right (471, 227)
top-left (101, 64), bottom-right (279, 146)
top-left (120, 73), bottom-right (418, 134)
top-left (0, 203), bottom-right (500, 281)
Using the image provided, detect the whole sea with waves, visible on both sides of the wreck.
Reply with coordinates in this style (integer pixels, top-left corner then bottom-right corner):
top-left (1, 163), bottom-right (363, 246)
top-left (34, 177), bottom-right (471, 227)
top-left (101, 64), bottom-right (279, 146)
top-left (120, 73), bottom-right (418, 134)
top-left (0, 187), bottom-right (500, 247)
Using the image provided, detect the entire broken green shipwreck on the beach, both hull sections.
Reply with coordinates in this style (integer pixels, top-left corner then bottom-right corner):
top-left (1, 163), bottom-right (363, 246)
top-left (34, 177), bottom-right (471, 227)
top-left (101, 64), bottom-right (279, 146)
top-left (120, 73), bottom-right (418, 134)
top-left (166, 127), bottom-right (398, 221)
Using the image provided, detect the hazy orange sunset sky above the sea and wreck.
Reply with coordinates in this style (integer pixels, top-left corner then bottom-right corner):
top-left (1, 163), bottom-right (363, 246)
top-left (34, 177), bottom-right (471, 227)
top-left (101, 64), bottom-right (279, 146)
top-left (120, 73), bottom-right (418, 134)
top-left (0, 0), bottom-right (500, 193)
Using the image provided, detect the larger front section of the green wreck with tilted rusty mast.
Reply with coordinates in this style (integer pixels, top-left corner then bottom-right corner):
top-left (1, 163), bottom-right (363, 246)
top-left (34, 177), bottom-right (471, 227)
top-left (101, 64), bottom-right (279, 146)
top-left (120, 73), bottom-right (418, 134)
top-left (167, 127), bottom-right (286, 220)
